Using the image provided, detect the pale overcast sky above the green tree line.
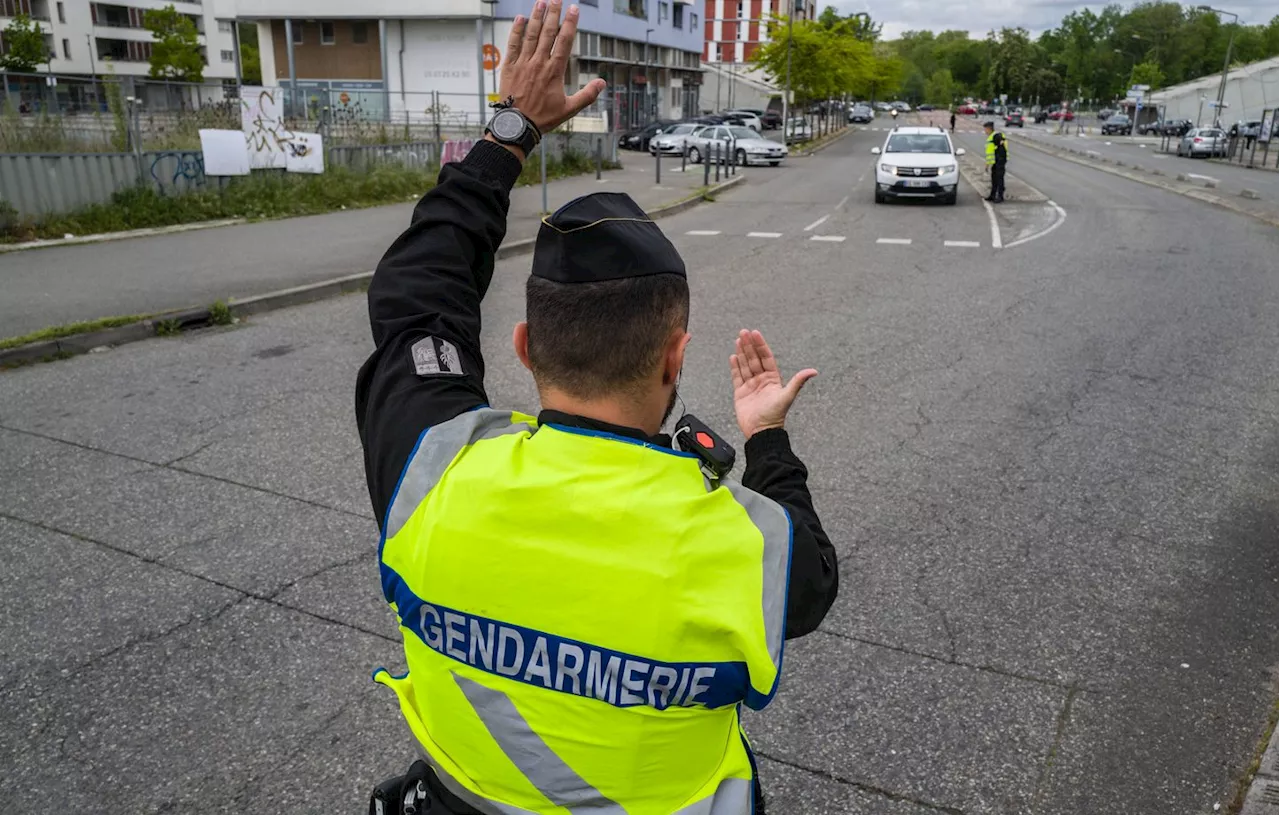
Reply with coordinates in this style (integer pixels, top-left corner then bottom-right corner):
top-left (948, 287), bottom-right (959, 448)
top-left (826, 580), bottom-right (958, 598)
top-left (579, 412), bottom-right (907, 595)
top-left (818, 0), bottom-right (1280, 40)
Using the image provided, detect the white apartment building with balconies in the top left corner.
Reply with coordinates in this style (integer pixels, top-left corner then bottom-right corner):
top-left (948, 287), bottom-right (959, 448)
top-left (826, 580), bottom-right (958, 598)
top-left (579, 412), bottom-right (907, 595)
top-left (0, 0), bottom-right (237, 82)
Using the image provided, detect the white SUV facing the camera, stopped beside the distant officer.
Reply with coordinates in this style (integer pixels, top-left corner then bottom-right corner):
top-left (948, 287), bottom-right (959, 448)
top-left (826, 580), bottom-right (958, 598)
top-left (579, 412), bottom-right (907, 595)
top-left (872, 127), bottom-right (964, 203)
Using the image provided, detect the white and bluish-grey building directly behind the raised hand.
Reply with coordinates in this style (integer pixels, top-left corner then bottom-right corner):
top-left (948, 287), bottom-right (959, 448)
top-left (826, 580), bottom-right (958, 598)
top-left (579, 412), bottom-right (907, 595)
top-left (218, 0), bottom-right (703, 128)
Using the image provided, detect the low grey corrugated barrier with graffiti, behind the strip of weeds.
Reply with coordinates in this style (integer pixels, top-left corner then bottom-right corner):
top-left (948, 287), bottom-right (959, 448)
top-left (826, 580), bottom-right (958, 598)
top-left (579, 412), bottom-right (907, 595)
top-left (0, 133), bottom-right (617, 219)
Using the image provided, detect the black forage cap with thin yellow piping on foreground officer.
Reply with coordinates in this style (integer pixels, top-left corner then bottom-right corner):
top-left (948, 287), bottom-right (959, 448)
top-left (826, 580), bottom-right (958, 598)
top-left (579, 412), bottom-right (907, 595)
top-left (532, 192), bottom-right (686, 283)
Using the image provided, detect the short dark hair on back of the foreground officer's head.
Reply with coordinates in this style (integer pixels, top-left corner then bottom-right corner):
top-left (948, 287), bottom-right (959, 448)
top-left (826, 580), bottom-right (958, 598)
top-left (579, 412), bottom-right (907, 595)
top-left (525, 274), bottom-right (689, 399)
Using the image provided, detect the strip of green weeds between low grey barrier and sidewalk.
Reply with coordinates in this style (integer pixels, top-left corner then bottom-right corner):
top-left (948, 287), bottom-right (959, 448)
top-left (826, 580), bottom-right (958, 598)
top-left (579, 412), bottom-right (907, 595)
top-left (0, 151), bottom-right (617, 243)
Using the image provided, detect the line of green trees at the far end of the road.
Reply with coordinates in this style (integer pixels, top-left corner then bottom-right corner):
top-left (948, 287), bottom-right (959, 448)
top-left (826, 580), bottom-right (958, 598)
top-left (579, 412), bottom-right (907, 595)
top-left (754, 1), bottom-right (1280, 105)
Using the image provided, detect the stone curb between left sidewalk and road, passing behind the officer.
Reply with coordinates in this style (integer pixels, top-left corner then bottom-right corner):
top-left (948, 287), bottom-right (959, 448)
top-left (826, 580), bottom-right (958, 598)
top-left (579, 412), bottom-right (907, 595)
top-left (0, 175), bottom-right (746, 370)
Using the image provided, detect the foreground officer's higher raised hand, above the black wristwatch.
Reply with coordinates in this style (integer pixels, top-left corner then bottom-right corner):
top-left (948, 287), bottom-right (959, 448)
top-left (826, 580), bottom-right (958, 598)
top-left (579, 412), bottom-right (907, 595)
top-left (498, 0), bottom-right (604, 133)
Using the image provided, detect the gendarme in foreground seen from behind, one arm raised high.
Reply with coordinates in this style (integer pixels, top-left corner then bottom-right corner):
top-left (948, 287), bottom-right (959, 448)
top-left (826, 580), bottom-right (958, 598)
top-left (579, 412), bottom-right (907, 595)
top-left (356, 0), bottom-right (837, 815)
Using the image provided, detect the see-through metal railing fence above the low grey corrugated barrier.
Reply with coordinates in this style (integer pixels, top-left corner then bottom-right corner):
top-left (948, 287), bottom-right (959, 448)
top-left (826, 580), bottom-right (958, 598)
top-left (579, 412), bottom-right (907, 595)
top-left (0, 72), bottom-right (617, 154)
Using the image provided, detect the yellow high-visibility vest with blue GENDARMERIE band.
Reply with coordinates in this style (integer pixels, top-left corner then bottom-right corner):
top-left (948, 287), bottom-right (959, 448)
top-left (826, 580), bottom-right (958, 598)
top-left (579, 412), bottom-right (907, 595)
top-left (375, 408), bottom-right (791, 815)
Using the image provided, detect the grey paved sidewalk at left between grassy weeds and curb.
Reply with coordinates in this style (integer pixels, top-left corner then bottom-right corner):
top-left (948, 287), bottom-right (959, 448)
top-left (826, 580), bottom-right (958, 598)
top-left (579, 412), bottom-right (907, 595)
top-left (0, 152), bottom-right (703, 336)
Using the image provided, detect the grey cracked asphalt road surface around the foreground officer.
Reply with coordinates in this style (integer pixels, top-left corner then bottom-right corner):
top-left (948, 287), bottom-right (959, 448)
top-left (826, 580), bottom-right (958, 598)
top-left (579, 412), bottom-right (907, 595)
top-left (0, 122), bottom-right (1280, 815)
